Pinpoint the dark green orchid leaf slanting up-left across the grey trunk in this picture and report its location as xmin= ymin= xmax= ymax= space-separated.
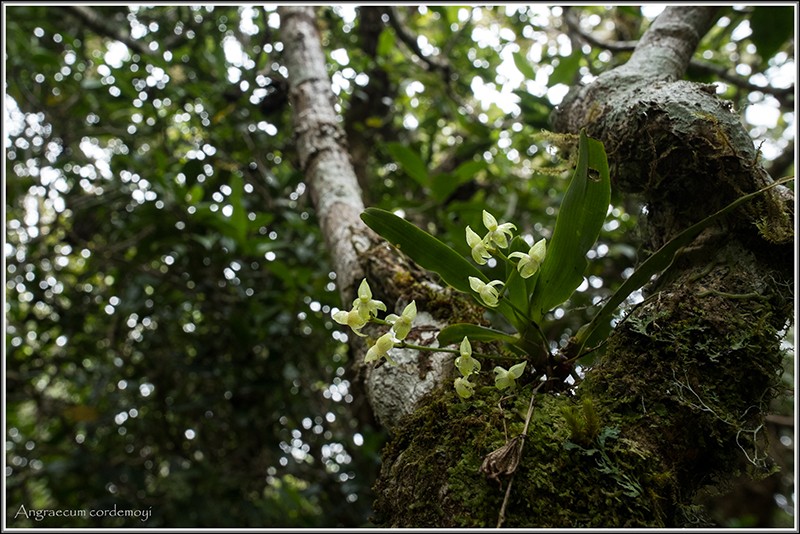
xmin=361 ymin=208 xmax=489 ymax=294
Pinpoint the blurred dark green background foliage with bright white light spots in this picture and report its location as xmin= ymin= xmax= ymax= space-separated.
xmin=4 ymin=5 xmax=796 ymax=527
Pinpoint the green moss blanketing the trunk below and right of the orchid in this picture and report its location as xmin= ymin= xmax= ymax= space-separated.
xmin=375 ymin=241 xmax=785 ymax=528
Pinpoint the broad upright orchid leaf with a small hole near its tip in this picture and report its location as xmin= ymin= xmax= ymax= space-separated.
xmin=531 ymin=130 xmax=611 ymax=323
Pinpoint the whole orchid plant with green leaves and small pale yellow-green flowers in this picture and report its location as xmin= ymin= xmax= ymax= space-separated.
xmin=333 ymin=131 xmax=785 ymax=398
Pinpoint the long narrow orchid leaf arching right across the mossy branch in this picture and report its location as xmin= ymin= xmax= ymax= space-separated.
xmin=575 ymin=176 xmax=794 ymax=354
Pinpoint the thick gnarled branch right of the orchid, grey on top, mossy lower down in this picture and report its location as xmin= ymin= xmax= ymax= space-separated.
xmin=553 ymin=2 xmax=793 ymax=524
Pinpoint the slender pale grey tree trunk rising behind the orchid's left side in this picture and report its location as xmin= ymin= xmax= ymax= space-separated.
xmin=278 ymin=6 xmax=452 ymax=428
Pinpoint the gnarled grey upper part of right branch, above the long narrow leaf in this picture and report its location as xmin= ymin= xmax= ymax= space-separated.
xmin=552 ymin=6 xmax=794 ymax=250
